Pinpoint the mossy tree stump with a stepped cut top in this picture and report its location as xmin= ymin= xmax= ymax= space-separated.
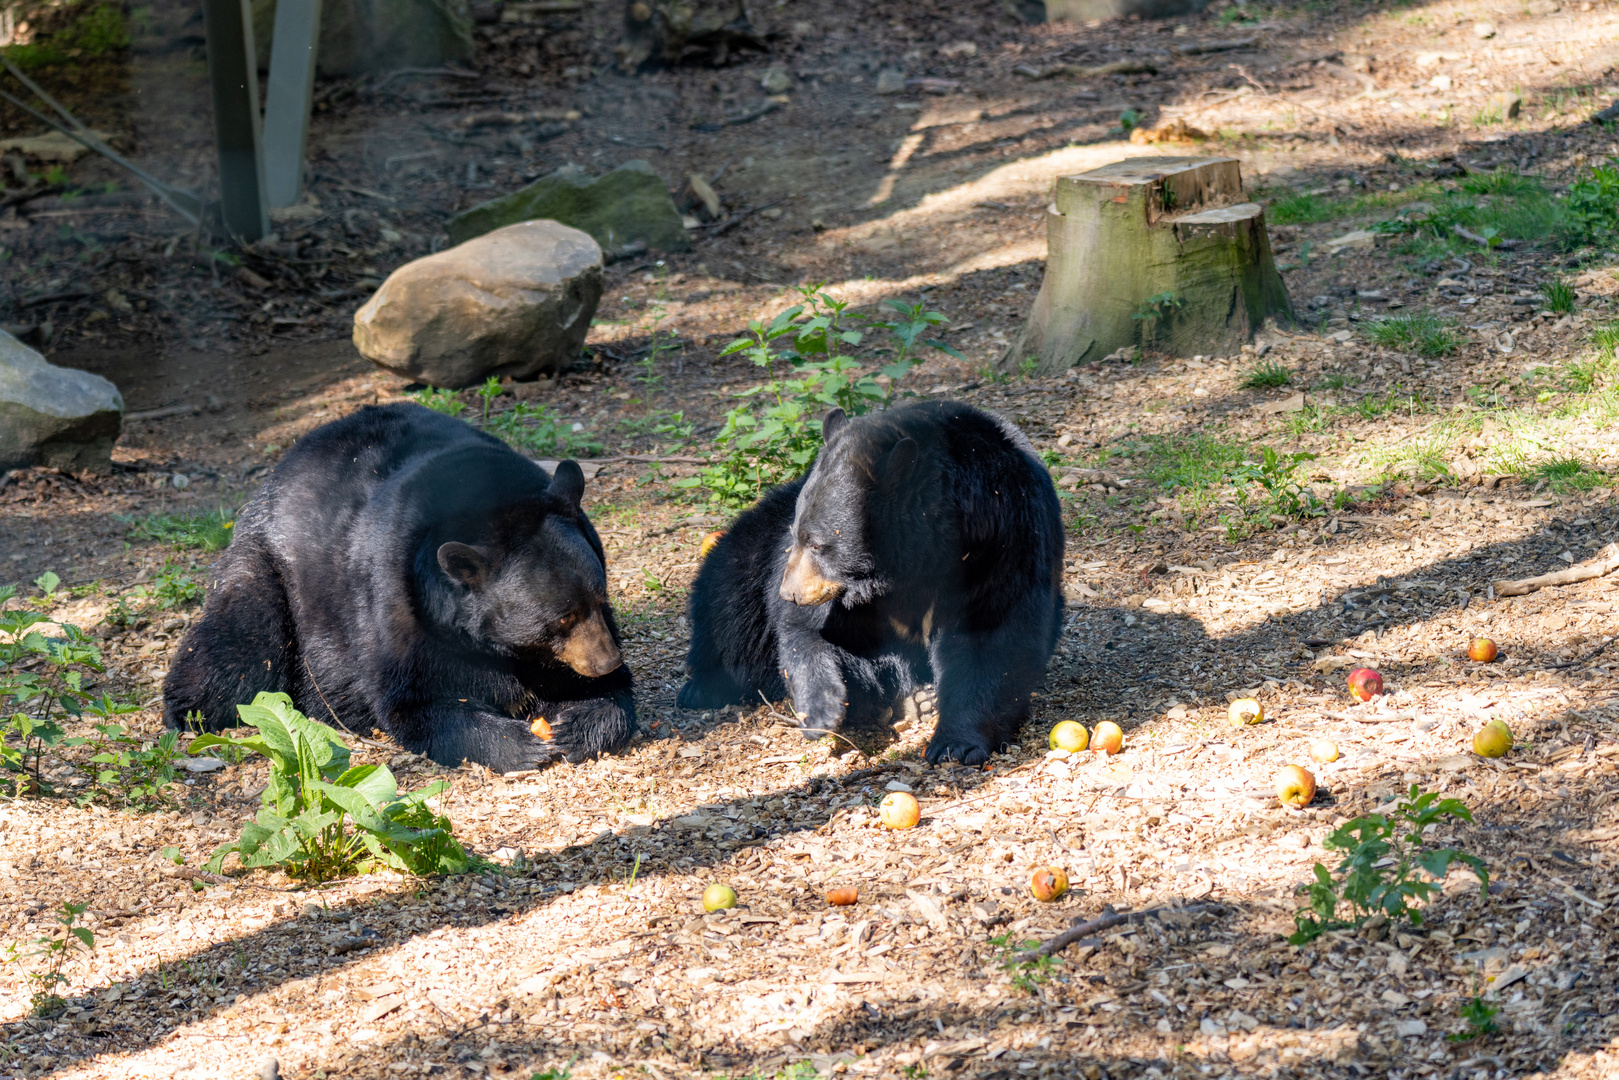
xmin=999 ymin=157 xmax=1294 ymax=376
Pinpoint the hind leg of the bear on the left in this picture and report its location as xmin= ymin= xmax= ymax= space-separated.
xmin=164 ymin=536 xmax=298 ymax=732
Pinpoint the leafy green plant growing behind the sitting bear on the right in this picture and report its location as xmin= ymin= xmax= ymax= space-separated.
xmin=675 ymin=283 xmax=967 ymax=507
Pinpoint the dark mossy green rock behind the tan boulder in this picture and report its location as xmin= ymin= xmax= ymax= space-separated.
xmin=445 ymin=160 xmax=691 ymax=251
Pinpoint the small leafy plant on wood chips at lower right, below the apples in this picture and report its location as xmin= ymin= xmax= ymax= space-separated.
xmin=1287 ymin=784 xmax=1489 ymax=946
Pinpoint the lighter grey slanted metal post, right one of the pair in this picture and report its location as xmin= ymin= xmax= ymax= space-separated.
xmin=264 ymin=0 xmax=321 ymax=207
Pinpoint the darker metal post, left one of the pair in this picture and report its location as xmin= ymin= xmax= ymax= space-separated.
xmin=202 ymin=0 xmax=270 ymax=241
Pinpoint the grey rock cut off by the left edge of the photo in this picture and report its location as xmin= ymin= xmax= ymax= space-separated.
xmin=0 ymin=330 xmax=123 ymax=473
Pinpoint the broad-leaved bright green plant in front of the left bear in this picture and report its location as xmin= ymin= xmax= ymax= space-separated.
xmin=189 ymin=693 xmax=468 ymax=881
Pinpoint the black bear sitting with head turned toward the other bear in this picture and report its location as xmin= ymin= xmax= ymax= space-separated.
xmin=678 ymin=402 xmax=1064 ymax=764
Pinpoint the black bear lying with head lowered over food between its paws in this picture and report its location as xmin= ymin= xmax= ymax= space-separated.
xmin=164 ymin=405 xmax=636 ymax=772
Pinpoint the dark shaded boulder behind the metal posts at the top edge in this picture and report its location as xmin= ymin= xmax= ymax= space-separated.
xmin=253 ymin=0 xmax=473 ymax=78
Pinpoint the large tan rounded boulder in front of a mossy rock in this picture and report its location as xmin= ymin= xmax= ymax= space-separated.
xmin=355 ymin=222 xmax=602 ymax=387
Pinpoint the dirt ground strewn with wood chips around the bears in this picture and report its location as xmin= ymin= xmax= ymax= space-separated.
xmin=0 ymin=0 xmax=1619 ymax=1080
